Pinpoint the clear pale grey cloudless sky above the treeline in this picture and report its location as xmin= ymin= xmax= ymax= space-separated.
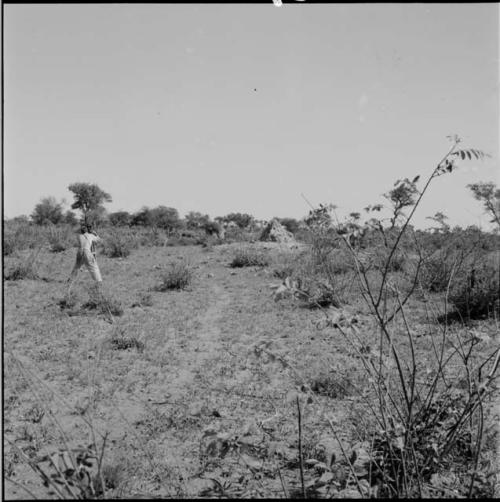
xmin=3 ymin=0 xmax=500 ymax=228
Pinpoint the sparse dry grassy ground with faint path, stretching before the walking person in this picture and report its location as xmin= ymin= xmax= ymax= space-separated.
xmin=4 ymin=244 xmax=498 ymax=499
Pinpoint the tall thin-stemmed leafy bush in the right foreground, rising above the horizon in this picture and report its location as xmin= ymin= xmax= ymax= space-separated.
xmin=280 ymin=138 xmax=500 ymax=498
